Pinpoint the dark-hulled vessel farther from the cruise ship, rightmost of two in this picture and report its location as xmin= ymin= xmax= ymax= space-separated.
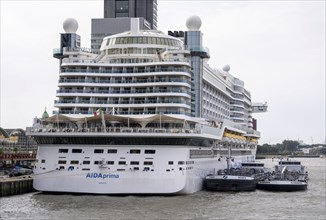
xmin=257 ymin=161 xmax=308 ymax=192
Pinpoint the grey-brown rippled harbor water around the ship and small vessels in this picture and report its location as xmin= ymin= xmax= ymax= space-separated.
xmin=0 ymin=158 xmax=326 ymax=220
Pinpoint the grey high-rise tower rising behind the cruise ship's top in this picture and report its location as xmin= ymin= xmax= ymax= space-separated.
xmin=91 ymin=0 xmax=157 ymax=50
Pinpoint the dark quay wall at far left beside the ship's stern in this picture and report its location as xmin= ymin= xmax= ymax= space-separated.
xmin=0 ymin=176 xmax=35 ymax=197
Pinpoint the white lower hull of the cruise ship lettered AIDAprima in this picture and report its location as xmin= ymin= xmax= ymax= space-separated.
xmin=33 ymin=146 xmax=253 ymax=194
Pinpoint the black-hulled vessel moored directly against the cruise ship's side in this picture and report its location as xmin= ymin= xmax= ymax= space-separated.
xmin=204 ymin=147 xmax=257 ymax=192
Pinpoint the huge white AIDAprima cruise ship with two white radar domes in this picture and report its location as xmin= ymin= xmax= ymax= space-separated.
xmin=27 ymin=13 xmax=267 ymax=195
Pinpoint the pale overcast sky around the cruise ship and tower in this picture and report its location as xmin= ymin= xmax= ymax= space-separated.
xmin=0 ymin=0 xmax=326 ymax=144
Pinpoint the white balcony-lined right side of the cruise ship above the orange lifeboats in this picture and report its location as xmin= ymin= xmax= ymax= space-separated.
xmin=203 ymin=65 xmax=252 ymax=128
